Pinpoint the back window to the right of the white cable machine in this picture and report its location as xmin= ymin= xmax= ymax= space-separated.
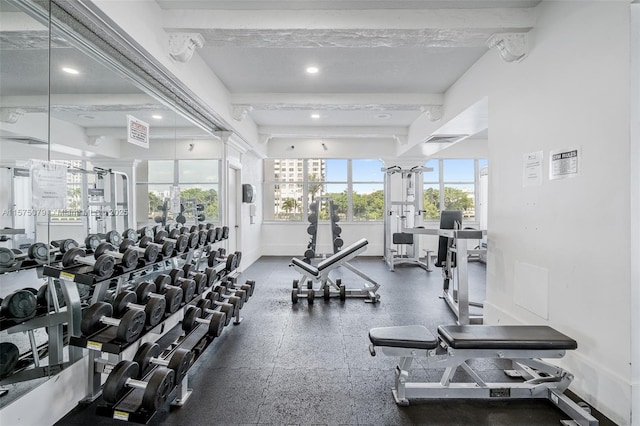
xmin=423 ymin=159 xmax=488 ymax=221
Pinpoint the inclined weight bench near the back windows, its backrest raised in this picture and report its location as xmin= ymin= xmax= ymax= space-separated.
xmin=289 ymin=238 xmax=380 ymax=303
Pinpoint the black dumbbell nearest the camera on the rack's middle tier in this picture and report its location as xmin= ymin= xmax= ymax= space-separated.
xmin=80 ymin=302 xmax=146 ymax=343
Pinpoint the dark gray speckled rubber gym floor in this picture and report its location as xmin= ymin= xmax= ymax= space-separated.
xmin=58 ymin=257 xmax=610 ymax=426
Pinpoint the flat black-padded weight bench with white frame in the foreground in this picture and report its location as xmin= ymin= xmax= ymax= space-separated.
xmin=369 ymin=325 xmax=598 ymax=426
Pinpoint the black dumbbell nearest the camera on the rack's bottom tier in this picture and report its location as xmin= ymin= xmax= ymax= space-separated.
xmin=102 ymin=360 xmax=175 ymax=412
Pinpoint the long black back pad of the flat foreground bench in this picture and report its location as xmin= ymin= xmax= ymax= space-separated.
xmin=438 ymin=325 xmax=578 ymax=350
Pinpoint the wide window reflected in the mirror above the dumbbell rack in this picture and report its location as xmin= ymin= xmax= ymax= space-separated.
xmin=136 ymin=160 xmax=220 ymax=223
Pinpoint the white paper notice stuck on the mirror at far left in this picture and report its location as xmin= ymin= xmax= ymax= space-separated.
xmin=31 ymin=160 xmax=67 ymax=210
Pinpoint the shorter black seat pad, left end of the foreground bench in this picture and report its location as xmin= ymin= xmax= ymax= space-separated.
xmin=369 ymin=325 xmax=438 ymax=349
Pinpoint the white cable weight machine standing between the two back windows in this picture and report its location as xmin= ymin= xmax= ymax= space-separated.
xmin=382 ymin=166 xmax=431 ymax=271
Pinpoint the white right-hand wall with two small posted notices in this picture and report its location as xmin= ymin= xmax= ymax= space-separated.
xmin=411 ymin=1 xmax=637 ymax=424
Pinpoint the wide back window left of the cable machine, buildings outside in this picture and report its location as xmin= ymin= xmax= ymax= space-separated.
xmin=264 ymin=159 xmax=384 ymax=221
